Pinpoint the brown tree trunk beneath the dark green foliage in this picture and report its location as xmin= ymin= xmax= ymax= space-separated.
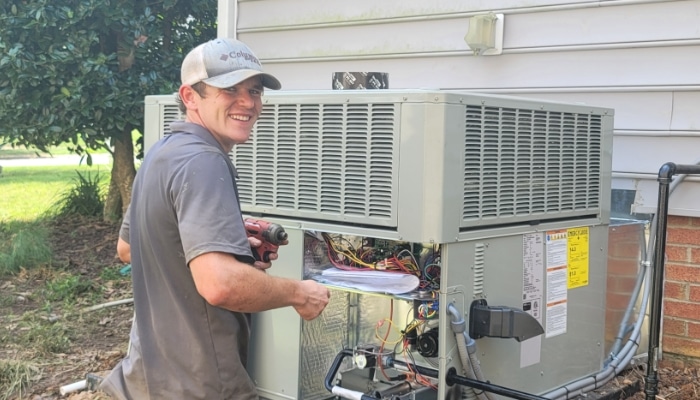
xmin=103 ymin=128 xmax=136 ymax=221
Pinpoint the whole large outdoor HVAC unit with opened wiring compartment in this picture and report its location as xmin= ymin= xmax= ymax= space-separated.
xmin=145 ymin=90 xmax=613 ymax=400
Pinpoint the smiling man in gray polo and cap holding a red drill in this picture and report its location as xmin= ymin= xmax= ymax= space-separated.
xmin=101 ymin=39 xmax=330 ymax=399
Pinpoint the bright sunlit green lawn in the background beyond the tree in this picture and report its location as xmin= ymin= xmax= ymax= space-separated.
xmin=0 ymin=165 xmax=111 ymax=223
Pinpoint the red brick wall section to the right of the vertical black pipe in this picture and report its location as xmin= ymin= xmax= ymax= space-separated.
xmin=661 ymin=216 xmax=700 ymax=358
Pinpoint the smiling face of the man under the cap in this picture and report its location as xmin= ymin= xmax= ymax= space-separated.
xmin=187 ymin=76 xmax=263 ymax=152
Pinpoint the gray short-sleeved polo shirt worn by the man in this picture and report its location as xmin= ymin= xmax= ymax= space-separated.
xmin=101 ymin=122 xmax=258 ymax=400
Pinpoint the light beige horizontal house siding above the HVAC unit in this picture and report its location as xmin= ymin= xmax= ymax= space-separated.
xmin=226 ymin=0 xmax=700 ymax=216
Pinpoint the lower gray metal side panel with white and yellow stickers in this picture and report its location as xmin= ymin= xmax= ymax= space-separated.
xmin=440 ymin=223 xmax=608 ymax=394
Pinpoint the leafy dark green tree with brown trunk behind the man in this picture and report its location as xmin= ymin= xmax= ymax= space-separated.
xmin=0 ymin=0 xmax=217 ymax=219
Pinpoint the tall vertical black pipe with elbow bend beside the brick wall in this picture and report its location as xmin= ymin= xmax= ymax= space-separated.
xmin=644 ymin=163 xmax=700 ymax=400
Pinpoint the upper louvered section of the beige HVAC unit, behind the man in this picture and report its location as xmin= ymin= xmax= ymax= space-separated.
xmin=145 ymin=90 xmax=613 ymax=243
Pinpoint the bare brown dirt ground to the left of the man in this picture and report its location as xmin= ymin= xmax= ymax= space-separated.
xmin=0 ymin=218 xmax=133 ymax=400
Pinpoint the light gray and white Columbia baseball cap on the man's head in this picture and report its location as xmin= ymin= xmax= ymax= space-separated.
xmin=180 ymin=38 xmax=282 ymax=89
